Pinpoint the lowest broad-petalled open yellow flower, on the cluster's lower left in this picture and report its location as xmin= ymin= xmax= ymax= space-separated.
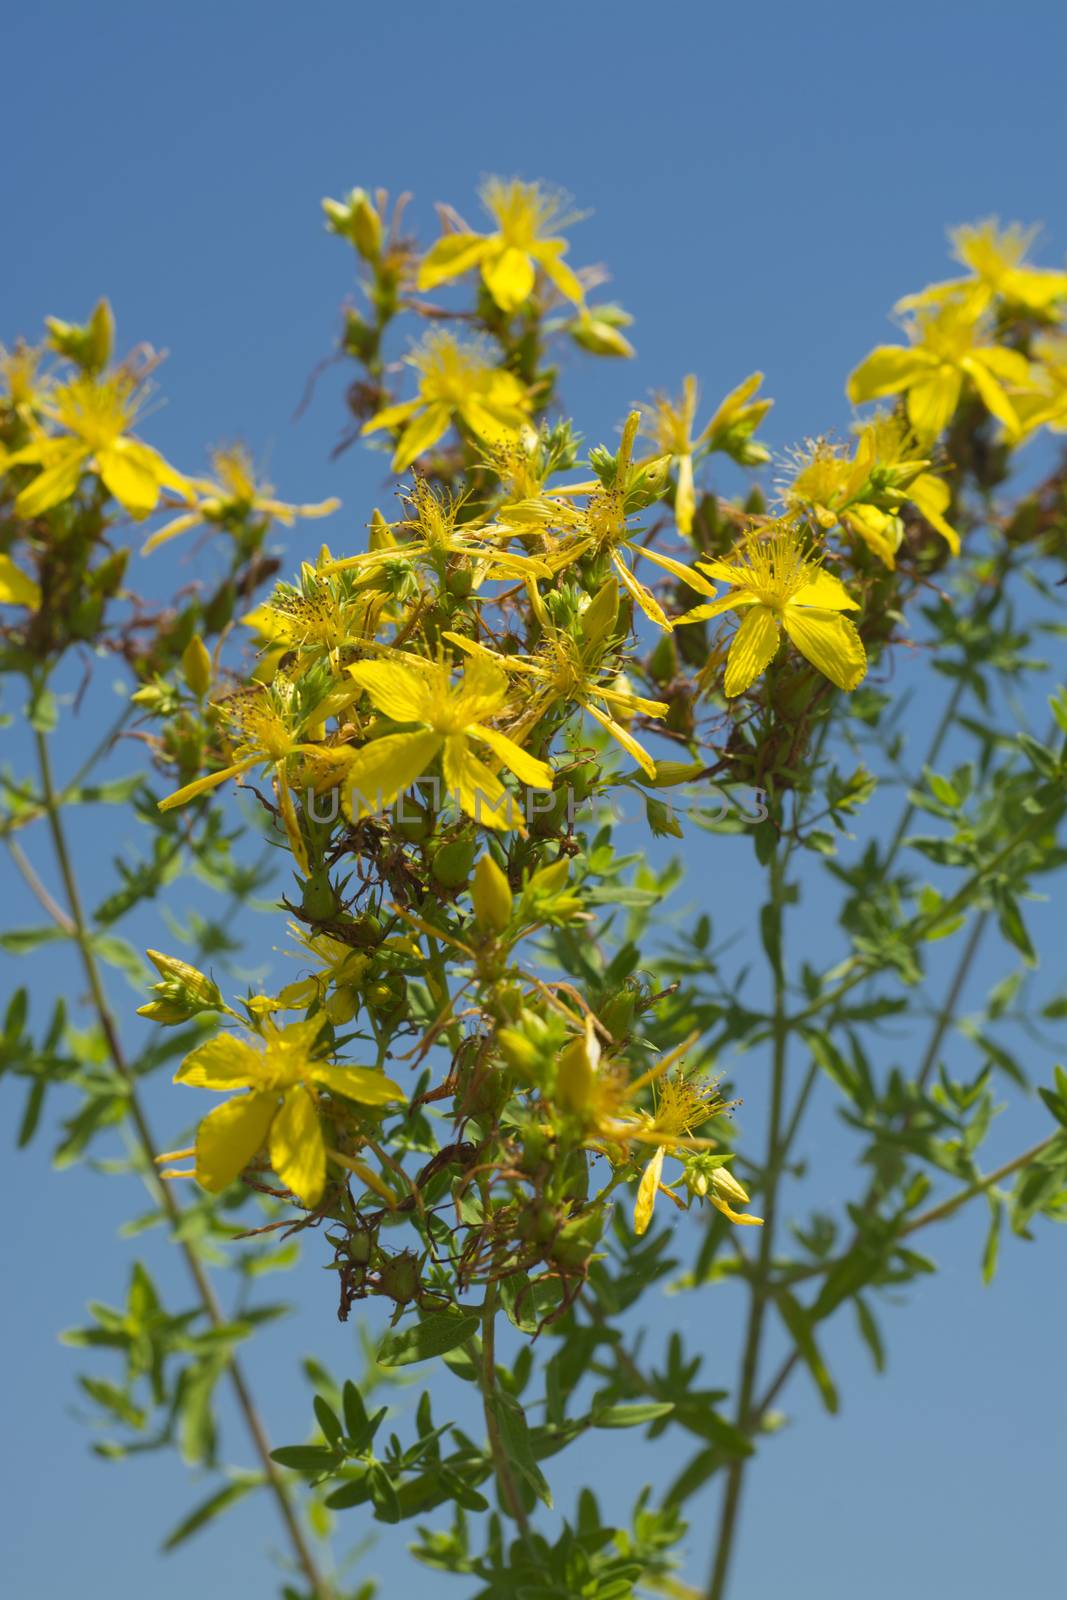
xmin=160 ymin=1016 xmax=405 ymax=1206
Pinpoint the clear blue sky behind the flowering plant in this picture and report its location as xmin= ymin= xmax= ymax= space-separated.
xmin=0 ymin=0 xmax=1067 ymax=1600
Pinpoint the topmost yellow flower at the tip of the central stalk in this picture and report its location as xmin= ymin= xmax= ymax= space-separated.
xmin=419 ymin=178 xmax=584 ymax=314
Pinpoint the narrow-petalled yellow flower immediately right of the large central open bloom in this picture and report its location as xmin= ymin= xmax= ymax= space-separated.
xmin=445 ymin=579 xmax=670 ymax=778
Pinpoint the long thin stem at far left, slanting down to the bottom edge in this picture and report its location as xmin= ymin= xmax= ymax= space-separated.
xmin=35 ymin=731 xmax=330 ymax=1600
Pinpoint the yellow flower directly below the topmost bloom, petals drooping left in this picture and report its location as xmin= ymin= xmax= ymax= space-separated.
xmin=363 ymin=330 xmax=531 ymax=472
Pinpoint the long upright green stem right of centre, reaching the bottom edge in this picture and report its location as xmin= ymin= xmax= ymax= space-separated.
xmin=707 ymin=851 xmax=789 ymax=1600
